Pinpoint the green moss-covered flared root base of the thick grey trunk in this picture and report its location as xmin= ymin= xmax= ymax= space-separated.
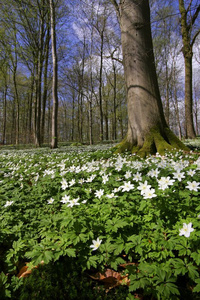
xmin=115 ymin=127 xmax=189 ymax=157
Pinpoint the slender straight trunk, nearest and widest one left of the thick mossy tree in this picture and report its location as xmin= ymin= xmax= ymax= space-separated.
xmin=49 ymin=0 xmax=58 ymax=149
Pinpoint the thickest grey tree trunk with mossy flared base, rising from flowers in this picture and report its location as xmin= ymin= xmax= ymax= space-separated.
xmin=112 ymin=0 xmax=189 ymax=156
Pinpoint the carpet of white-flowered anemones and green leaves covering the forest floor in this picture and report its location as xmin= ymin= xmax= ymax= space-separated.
xmin=0 ymin=145 xmax=200 ymax=300
